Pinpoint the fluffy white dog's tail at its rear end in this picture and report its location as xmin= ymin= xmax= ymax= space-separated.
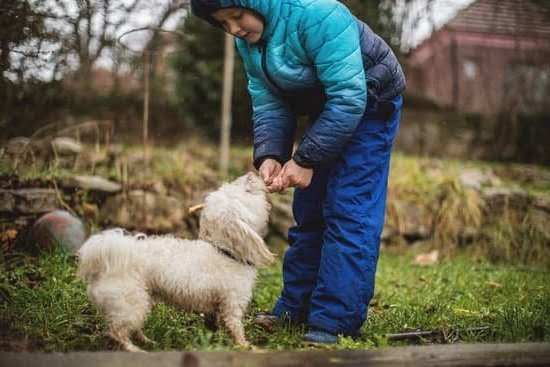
xmin=77 ymin=228 xmax=139 ymax=281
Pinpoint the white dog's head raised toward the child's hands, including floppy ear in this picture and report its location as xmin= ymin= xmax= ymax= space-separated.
xmin=199 ymin=172 xmax=274 ymax=265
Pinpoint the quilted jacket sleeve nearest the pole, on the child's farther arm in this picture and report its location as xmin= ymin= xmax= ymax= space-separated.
xmin=237 ymin=40 xmax=296 ymax=168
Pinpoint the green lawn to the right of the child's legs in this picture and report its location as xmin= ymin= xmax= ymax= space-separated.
xmin=365 ymin=249 xmax=550 ymax=342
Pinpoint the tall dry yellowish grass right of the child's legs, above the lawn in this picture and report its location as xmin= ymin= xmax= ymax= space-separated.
xmin=386 ymin=154 xmax=550 ymax=266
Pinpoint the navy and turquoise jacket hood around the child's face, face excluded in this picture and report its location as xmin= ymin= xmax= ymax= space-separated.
xmin=191 ymin=0 xmax=283 ymax=39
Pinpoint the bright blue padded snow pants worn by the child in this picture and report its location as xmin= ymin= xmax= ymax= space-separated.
xmin=273 ymin=96 xmax=402 ymax=336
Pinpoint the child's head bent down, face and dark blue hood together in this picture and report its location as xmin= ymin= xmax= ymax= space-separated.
xmin=191 ymin=0 xmax=269 ymax=43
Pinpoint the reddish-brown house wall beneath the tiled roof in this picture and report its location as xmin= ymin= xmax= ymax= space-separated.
xmin=406 ymin=28 xmax=550 ymax=114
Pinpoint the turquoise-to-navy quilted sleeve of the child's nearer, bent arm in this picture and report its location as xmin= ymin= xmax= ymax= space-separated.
xmin=294 ymin=1 xmax=367 ymax=167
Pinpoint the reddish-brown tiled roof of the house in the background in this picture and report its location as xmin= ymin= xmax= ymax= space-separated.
xmin=447 ymin=0 xmax=550 ymax=38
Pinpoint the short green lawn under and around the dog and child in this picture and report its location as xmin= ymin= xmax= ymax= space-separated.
xmin=0 ymin=248 xmax=550 ymax=352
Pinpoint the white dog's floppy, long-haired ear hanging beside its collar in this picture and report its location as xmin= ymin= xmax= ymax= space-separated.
xmin=225 ymin=218 xmax=275 ymax=266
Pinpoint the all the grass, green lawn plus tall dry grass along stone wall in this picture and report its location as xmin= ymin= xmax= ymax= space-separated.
xmin=0 ymin=139 xmax=550 ymax=352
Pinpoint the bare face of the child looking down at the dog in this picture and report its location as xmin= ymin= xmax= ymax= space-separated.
xmin=212 ymin=8 xmax=264 ymax=43
